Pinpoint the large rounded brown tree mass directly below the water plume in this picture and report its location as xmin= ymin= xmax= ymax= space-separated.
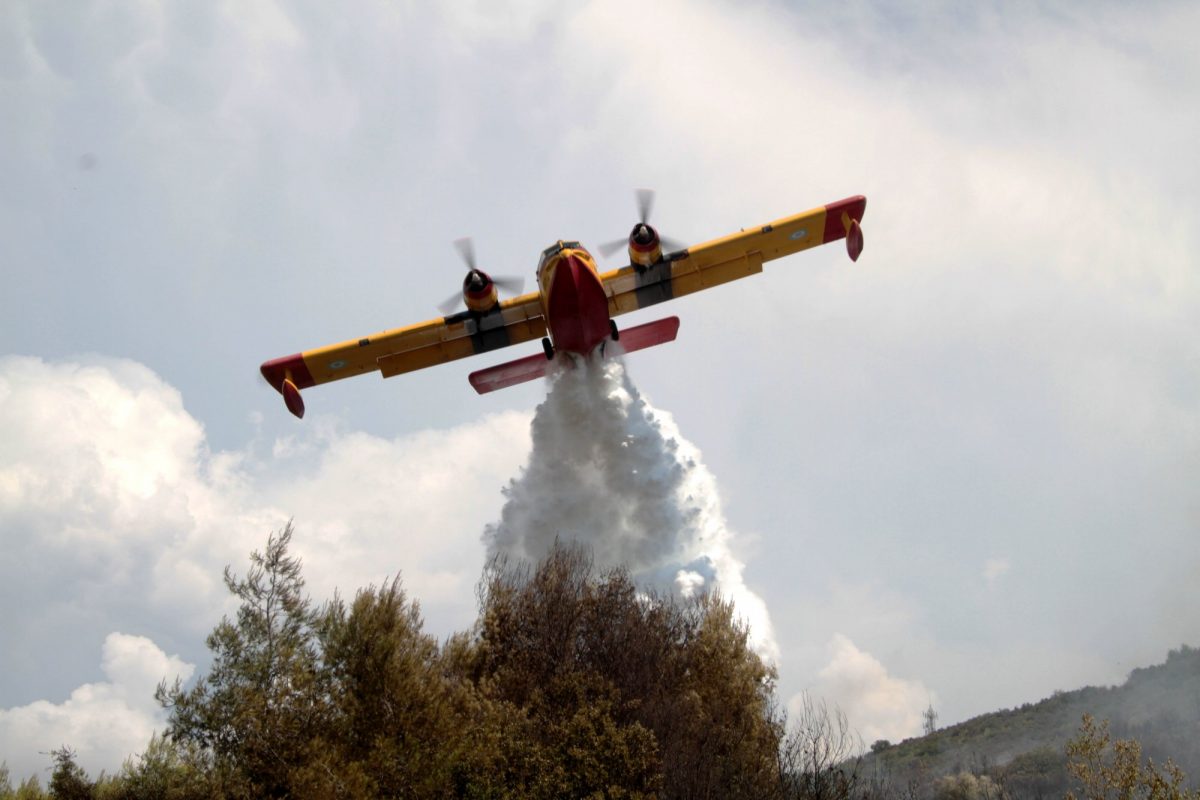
xmin=451 ymin=545 xmax=780 ymax=798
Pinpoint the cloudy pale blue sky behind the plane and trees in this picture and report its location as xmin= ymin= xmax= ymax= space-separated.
xmin=0 ymin=0 xmax=1200 ymax=776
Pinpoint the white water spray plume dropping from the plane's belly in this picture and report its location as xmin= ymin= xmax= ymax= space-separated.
xmin=484 ymin=350 xmax=779 ymax=663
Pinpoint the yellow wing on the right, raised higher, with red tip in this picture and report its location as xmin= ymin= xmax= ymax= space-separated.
xmin=600 ymin=196 xmax=866 ymax=317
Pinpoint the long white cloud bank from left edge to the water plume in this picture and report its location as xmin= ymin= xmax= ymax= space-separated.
xmin=0 ymin=357 xmax=529 ymax=769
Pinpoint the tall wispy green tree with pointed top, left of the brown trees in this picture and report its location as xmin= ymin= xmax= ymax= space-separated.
xmin=156 ymin=522 xmax=328 ymax=796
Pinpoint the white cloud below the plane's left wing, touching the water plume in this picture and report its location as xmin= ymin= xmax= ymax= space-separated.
xmin=259 ymin=411 xmax=529 ymax=633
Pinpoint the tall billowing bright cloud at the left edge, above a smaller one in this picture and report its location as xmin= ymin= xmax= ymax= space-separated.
xmin=0 ymin=357 xmax=279 ymax=681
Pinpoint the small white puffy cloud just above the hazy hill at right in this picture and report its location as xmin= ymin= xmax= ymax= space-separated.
xmin=788 ymin=633 xmax=936 ymax=742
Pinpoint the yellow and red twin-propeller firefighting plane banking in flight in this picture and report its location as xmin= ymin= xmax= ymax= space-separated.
xmin=262 ymin=190 xmax=866 ymax=417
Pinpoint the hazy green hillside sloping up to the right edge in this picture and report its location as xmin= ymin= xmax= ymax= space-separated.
xmin=860 ymin=645 xmax=1200 ymax=796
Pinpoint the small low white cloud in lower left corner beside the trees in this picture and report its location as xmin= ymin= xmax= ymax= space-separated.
xmin=0 ymin=633 xmax=194 ymax=780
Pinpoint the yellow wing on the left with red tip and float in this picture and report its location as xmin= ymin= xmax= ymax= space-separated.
xmin=260 ymin=291 xmax=546 ymax=416
